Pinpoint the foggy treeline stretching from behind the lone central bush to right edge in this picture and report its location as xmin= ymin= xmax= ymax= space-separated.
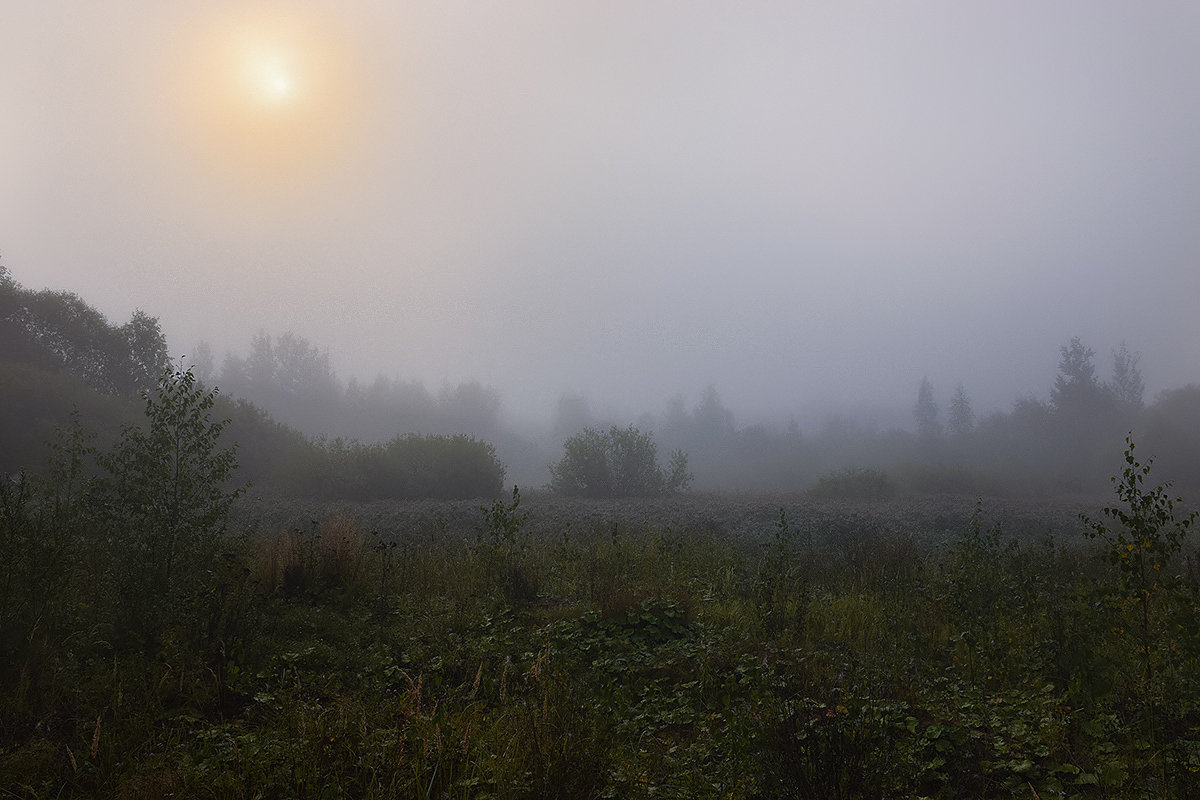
xmin=553 ymin=338 xmax=1200 ymax=494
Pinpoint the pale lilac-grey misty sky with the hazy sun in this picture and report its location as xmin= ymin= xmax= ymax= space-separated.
xmin=0 ymin=0 xmax=1200 ymax=429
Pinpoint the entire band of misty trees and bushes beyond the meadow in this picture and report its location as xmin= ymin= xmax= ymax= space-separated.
xmin=0 ymin=266 xmax=1200 ymax=499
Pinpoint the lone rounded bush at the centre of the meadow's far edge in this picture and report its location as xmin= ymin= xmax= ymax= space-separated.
xmin=550 ymin=426 xmax=691 ymax=498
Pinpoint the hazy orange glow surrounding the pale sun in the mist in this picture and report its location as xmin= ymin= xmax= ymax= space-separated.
xmin=165 ymin=5 xmax=365 ymax=204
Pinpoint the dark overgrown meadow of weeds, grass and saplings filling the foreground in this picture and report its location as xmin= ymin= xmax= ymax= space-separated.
xmin=0 ymin=373 xmax=1200 ymax=798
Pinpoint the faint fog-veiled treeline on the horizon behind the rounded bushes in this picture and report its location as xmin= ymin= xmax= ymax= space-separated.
xmin=162 ymin=280 xmax=1200 ymax=494
